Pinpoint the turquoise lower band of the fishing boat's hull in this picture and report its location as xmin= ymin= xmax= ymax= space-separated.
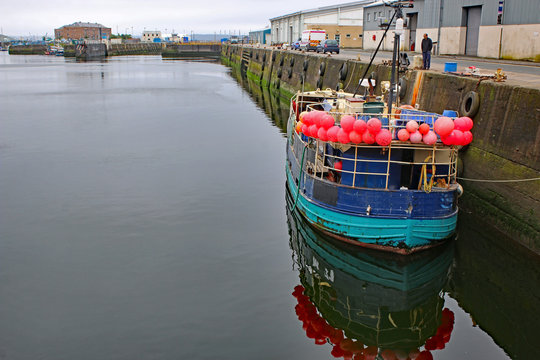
xmin=287 ymin=166 xmax=457 ymax=254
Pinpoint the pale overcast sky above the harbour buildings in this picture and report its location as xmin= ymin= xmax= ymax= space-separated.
xmin=0 ymin=0 xmax=350 ymax=36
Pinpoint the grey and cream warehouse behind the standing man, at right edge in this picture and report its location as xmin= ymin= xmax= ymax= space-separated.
xmin=364 ymin=0 xmax=540 ymax=59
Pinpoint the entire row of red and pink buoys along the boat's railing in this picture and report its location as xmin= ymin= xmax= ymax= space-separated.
xmin=296 ymin=110 xmax=473 ymax=146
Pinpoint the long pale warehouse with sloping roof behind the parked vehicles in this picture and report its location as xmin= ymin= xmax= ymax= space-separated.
xmin=270 ymin=0 xmax=374 ymax=48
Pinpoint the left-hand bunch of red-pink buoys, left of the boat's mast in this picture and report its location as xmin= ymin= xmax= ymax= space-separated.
xmin=296 ymin=111 xmax=392 ymax=146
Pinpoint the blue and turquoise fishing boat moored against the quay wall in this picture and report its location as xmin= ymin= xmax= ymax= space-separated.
xmin=286 ymin=1 xmax=472 ymax=254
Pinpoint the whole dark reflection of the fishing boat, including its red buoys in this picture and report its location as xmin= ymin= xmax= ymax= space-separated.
xmin=287 ymin=196 xmax=454 ymax=360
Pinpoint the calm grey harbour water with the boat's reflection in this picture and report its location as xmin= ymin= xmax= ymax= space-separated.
xmin=0 ymin=53 xmax=540 ymax=360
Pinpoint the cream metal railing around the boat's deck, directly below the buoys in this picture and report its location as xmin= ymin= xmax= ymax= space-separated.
xmin=296 ymin=134 xmax=457 ymax=191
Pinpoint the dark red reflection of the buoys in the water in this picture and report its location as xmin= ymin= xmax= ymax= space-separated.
xmin=292 ymin=285 xmax=454 ymax=360
